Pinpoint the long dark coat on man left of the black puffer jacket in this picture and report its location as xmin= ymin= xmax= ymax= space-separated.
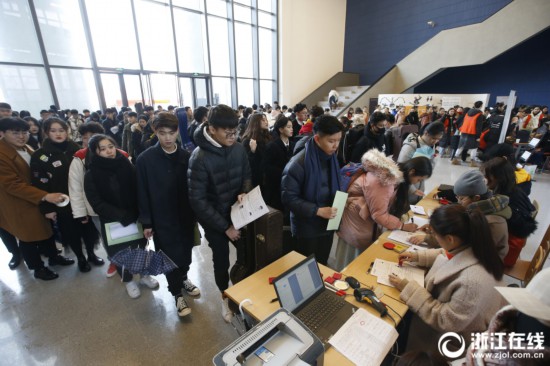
xmin=136 ymin=143 xmax=195 ymax=266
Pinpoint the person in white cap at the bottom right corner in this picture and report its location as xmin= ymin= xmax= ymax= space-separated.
xmin=466 ymin=268 xmax=550 ymax=366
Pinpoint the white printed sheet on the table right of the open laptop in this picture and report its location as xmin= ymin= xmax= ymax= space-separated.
xmin=329 ymin=309 xmax=398 ymax=366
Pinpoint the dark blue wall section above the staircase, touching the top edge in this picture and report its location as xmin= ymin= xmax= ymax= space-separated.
xmin=344 ymin=0 xmax=511 ymax=85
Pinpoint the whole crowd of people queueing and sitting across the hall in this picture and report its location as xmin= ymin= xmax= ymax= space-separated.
xmin=0 ymin=96 xmax=550 ymax=360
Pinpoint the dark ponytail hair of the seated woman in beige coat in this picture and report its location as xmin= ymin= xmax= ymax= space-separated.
xmin=430 ymin=204 xmax=504 ymax=281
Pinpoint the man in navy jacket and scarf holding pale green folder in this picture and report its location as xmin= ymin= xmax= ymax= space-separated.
xmin=281 ymin=114 xmax=343 ymax=265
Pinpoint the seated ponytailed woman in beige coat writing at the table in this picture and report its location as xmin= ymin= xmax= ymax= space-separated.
xmin=390 ymin=204 xmax=504 ymax=350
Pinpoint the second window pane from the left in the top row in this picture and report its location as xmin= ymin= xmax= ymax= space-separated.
xmin=34 ymin=0 xmax=92 ymax=67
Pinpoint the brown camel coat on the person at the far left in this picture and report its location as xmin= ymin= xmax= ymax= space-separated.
xmin=0 ymin=140 xmax=53 ymax=242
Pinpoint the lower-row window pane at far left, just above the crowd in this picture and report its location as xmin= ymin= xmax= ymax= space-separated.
xmin=0 ymin=65 xmax=53 ymax=116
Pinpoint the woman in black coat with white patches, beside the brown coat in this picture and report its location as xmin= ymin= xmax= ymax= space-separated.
xmin=30 ymin=117 xmax=105 ymax=272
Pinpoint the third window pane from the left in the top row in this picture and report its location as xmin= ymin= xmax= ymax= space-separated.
xmin=86 ymin=0 xmax=143 ymax=69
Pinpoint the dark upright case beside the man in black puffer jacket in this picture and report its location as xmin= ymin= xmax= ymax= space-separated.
xmin=254 ymin=207 xmax=284 ymax=271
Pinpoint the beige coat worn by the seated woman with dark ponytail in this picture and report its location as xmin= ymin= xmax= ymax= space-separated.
xmin=401 ymin=248 xmax=504 ymax=350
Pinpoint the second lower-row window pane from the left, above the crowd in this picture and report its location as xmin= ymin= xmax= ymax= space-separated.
xmin=52 ymin=68 xmax=99 ymax=112
